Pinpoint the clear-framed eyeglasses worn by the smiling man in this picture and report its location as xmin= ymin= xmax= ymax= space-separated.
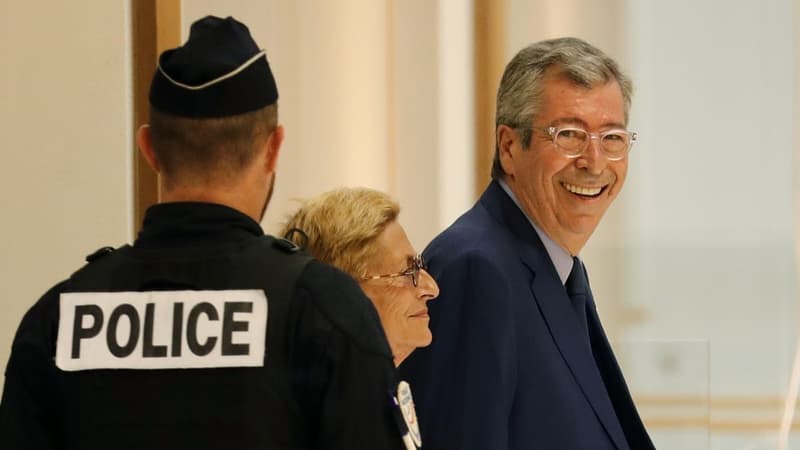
xmin=533 ymin=127 xmax=636 ymax=161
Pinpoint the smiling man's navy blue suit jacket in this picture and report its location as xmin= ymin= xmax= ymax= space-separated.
xmin=400 ymin=182 xmax=653 ymax=450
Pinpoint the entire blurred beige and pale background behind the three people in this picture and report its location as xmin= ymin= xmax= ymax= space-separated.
xmin=0 ymin=0 xmax=800 ymax=450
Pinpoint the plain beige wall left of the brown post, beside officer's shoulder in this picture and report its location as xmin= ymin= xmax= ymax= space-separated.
xmin=0 ymin=1 xmax=131 ymax=394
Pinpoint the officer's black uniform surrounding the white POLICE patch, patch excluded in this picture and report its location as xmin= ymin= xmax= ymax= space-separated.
xmin=0 ymin=203 xmax=402 ymax=449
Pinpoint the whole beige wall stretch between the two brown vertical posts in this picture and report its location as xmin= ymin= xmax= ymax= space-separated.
xmin=182 ymin=0 xmax=472 ymax=250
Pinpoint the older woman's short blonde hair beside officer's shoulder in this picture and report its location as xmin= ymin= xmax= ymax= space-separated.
xmin=281 ymin=188 xmax=400 ymax=279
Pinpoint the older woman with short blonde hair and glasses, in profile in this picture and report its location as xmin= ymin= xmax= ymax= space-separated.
xmin=282 ymin=188 xmax=439 ymax=365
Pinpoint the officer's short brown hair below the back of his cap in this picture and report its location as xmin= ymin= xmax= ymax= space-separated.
xmin=150 ymin=103 xmax=278 ymax=185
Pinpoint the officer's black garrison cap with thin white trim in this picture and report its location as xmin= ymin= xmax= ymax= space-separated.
xmin=150 ymin=16 xmax=278 ymax=118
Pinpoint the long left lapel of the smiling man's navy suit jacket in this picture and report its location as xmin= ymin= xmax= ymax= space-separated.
xmin=480 ymin=181 xmax=628 ymax=450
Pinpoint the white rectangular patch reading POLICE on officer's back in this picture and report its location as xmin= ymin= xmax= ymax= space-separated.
xmin=56 ymin=289 xmax=268 ymax=371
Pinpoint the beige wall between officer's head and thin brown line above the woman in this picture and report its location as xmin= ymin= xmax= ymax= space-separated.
xmin=182 ymin=0 xmax=390 ymax=237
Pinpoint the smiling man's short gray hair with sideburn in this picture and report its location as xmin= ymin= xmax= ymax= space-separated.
xmin=492 ymin=37 xmax=633 ymax=179
